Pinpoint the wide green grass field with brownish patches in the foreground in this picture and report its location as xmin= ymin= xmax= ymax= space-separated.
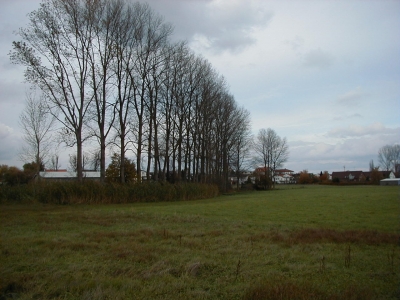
xmin=0 ymin=186 xmax=400 ymax=299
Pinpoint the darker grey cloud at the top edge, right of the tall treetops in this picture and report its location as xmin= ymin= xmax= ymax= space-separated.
xmin=144 ymin=0 xmax=272 ymax=53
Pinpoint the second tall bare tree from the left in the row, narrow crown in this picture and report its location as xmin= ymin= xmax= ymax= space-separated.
xmin=86 ymin=1 xmax=119 ymax=181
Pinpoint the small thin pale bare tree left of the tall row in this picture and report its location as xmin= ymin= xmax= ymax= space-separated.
xmin=19 ymin=90 xmax=54 ymax=172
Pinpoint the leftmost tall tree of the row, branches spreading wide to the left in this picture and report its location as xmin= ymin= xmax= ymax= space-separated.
xmin=10 ymin=0 xmax=93 ymax=181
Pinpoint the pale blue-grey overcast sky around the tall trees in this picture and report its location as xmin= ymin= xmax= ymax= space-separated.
xmin=0 ymin=0 xmax=400 ymax=172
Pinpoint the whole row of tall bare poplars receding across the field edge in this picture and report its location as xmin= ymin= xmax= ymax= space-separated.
xmin=10 ymin=0 xmax=250 ymax=189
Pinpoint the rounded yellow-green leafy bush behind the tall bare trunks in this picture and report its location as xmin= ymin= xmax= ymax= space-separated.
xmin=106 ymin=153 xmax=137 ymax=183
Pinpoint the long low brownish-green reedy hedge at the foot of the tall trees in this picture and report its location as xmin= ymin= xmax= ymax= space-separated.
xmin=0 ymin=181 xmax=219 ymax=204
